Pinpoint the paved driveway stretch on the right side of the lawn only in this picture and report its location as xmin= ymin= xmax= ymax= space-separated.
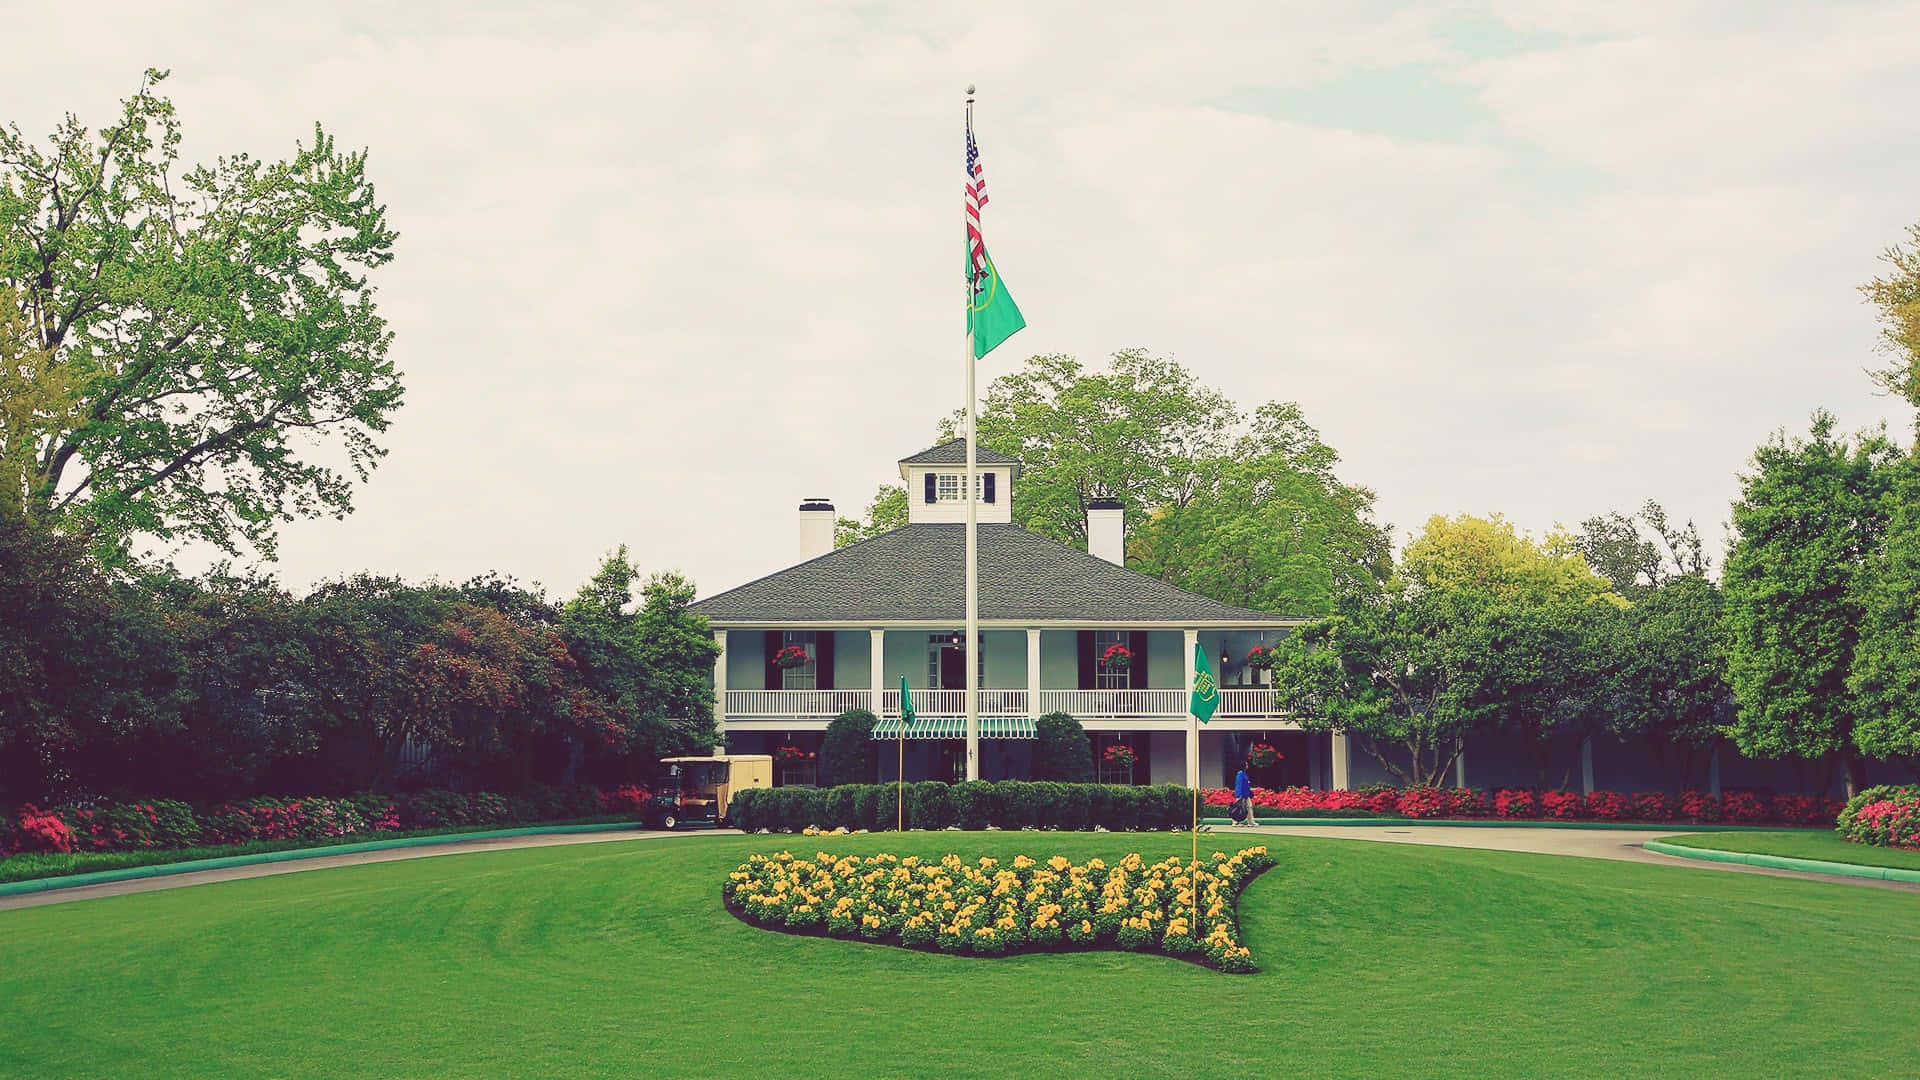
xmin=1213 ymin=824 xmax=1920 ymax=892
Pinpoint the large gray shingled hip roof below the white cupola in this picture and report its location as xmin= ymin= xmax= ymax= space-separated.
xmin=693 ymin=525 xmax=1292 ymax=626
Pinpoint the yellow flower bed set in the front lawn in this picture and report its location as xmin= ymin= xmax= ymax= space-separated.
xmin=720 ymin=846 xmax=1273 ymax=972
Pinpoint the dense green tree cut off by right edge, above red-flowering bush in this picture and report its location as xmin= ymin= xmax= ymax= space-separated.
xmin=1847 ymin=448 xmax=1920 ymax=776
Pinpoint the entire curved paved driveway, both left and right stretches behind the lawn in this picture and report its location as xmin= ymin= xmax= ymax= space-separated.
xmin=0 ymin=824 xmax=1920 ymax=911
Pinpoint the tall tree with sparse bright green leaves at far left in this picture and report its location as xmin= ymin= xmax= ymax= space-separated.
xmin=0 ymin=71 xmax=401 ymax=559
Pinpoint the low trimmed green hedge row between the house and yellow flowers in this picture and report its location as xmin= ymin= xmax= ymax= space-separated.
xmin=728 ymin=780 xmax=1194 ymax=832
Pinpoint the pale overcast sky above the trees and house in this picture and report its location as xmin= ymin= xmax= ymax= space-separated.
xmin=0 ymin=0 xmax=1920 ymax=596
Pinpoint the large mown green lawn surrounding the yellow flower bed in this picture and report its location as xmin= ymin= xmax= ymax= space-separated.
xmin=0 ymin=832 xmax=1920 ymax=1078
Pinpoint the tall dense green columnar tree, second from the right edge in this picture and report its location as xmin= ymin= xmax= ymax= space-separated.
xmin=1724 ymin=409 xmax=1897 ymax=792
